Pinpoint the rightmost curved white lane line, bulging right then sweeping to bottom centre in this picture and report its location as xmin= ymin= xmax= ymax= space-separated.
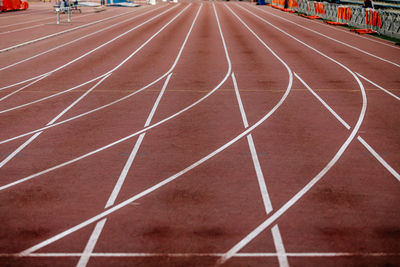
xmin=217 ymin=3 xmax=367 ymax=264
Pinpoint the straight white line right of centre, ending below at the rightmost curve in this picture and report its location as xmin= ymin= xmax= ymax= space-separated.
xmin=232 ymin=73 xmax=273 ymax=214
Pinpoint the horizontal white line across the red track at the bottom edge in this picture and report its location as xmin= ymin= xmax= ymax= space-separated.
xmin=0 ymin=252 xmax=400 ymax=258
